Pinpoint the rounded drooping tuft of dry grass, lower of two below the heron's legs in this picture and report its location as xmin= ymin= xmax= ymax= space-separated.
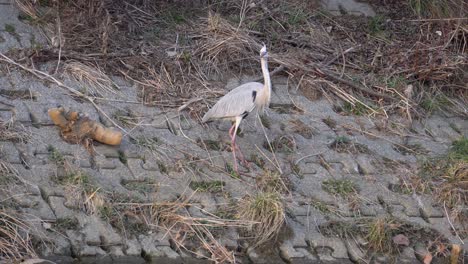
xmin=238 ymin=192 xmax=286 ymax=247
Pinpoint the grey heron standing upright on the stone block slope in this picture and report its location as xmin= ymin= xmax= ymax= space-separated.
xmin=202 ymin=44 xmax=271 ymax=172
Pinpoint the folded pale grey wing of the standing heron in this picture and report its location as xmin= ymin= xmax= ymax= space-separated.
xmin=202 ymin=83 xmax=263 ymax=122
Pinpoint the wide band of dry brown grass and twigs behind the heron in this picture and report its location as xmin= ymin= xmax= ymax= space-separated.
xmin=12 ymin=0 xmax=468 ymax=119
